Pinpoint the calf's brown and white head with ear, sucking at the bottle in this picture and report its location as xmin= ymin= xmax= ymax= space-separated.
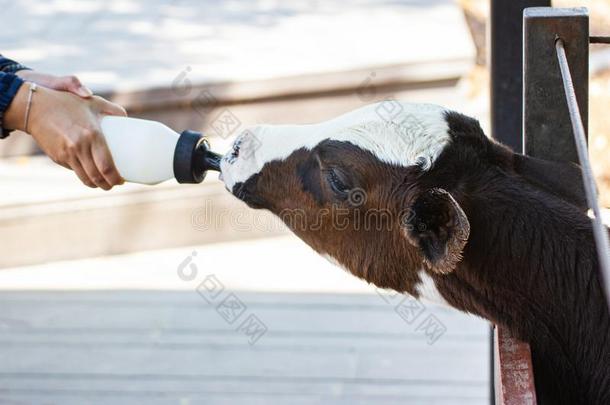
xmin=221 ymin=102 xmax=584 ymax=297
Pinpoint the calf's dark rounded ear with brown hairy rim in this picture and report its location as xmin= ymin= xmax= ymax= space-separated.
xmin=402 ymin=188 xmax=470 ymax=274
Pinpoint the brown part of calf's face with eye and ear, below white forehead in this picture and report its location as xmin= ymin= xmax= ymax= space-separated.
xmin=228 ymin=136 xmax=470 ymax=296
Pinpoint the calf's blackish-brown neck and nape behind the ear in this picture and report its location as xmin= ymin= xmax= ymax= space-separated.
xmin=426 ymin=114 xmax=610 ymax=404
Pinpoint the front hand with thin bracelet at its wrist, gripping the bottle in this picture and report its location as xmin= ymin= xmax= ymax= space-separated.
xmin=4 ymin=83 xmax=127 ymax=190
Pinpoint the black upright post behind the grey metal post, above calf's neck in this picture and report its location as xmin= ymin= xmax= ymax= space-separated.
xmin=490 ymin=0 xmax=551 ymax=152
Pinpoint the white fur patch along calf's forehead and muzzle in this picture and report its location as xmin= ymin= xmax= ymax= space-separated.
xmin=221 ymin=100 xmax=450 ymax=190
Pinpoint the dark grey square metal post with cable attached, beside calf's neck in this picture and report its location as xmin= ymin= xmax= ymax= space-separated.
xmin=523 ymin=7 xmax=589 ymax=159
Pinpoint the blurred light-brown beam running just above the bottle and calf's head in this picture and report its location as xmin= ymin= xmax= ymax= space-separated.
xmin=101 ymin=64 xmax=460 ymax=114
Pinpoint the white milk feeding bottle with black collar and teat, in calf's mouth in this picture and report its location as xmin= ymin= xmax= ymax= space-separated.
xmin=101 ymin=116 xmax=221 ymax=184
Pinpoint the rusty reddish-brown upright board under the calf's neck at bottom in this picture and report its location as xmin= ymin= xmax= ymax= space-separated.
xmin=494 ymin=326 xmax=536 ymax=405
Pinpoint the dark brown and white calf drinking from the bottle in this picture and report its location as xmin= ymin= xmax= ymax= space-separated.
xmin=221 ymin=103 xmax=610 ymax=404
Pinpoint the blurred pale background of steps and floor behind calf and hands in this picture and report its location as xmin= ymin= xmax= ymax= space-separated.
xmin=0 ymin=0 xmax=610 ymax=404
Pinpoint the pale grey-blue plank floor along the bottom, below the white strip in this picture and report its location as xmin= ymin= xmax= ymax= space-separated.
xmin=0 ymin=291 xmax=488 ymax=404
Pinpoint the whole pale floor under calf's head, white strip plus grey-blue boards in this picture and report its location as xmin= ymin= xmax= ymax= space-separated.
xmin=0 ymin=236 xmax=489 ymax=405
